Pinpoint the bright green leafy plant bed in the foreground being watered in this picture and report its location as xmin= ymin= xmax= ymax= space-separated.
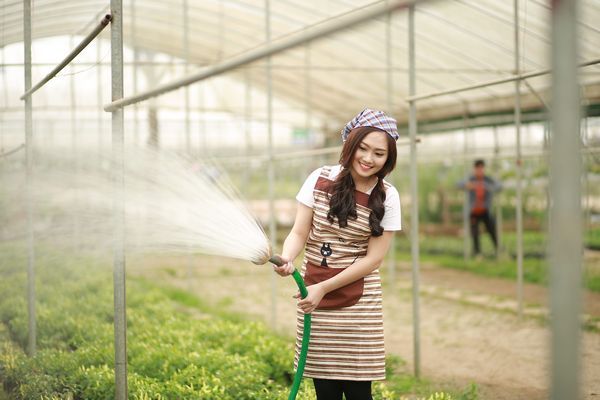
xmin=0 ymin=245 xmax=464 ymax=400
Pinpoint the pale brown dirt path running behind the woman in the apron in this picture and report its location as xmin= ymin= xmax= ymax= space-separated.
xmin=128 ymin=257 xmax=600 ymax=400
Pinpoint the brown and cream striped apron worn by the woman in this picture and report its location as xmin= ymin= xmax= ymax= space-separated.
xmin=294 ymin=167 xmax=389 ymax=381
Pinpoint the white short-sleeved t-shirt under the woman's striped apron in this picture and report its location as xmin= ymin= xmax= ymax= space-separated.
xmin=296 ymin=165 xmax=402 ymax=231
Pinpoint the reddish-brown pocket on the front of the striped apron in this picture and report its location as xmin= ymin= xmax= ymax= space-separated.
xmin=304 ymin=262 xmax=365 ymax=309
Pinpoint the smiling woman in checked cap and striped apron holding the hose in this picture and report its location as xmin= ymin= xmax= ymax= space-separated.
xmin=273 ymin=109 xmax=401 ymax=400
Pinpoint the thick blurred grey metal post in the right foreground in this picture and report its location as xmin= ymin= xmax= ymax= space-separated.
xmin=548 ymin=0 xmax=583 ymax=400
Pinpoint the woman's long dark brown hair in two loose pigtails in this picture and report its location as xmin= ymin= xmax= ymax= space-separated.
xmin=327 ymin=126 xmax=397 ymax=236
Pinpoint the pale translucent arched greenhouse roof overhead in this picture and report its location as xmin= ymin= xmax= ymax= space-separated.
xmin=0 ymin=0 xmax=600 ymax=129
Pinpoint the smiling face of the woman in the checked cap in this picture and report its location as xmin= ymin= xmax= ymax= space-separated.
xmin=352 ymin=131 xmax=388 ymax=178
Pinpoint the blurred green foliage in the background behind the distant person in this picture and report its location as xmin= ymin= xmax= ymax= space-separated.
xmin=224 ymin=154 xmax=600 ymax=234
